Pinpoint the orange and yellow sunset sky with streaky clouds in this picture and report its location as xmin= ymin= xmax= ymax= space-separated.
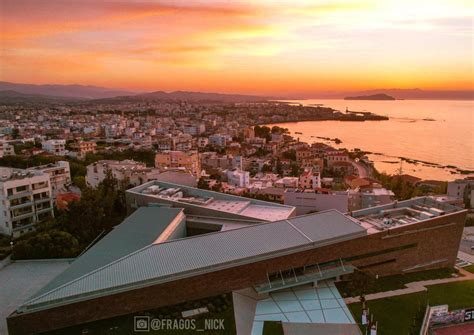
xmin=0 ymin=0 xmax=474 ymax=94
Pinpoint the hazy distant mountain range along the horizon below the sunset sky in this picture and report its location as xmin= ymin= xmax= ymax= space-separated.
xmin=0 ymin=81 xmax=474 ymax=103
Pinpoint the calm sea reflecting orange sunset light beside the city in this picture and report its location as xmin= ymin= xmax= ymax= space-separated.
xmin=268 ymin=99 xmax=474 ymax=180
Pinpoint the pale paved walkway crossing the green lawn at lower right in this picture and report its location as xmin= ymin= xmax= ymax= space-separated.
xmin=344 ymin=269 xmax=474 ymax=304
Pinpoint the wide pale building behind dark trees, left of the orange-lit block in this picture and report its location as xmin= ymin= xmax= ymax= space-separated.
xmin=86 ymin=160 xmax=161 ymax=188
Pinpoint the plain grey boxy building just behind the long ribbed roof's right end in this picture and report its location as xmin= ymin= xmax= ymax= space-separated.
xmin=284 ymin=189 xmax=349 ymax=215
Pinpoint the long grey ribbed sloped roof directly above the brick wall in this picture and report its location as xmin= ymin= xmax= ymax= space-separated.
xmin=21 ymin=210 xmax=366 ymax=310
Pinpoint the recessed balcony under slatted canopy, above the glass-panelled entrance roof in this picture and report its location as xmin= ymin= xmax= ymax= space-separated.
xmin=254 ymin=261 xmax=356 ymax=293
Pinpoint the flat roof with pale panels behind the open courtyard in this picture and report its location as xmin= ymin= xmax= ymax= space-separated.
xmin=127 ymin=181 xmax=295 ymax=221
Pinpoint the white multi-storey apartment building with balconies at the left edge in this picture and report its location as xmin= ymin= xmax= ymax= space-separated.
xmin=0 ymin=167 xmax=54 ymax=237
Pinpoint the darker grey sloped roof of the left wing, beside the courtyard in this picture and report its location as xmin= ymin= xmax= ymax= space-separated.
xmin=27 ymin=207 xmax=183 ymax=297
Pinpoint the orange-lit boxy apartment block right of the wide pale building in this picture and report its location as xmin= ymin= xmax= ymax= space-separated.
xmin=155 ymin=150 xmax=201 ymax=179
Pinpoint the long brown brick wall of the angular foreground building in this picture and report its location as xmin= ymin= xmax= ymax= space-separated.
xmin=7 ymin=212 xmax=466 ymax=335
